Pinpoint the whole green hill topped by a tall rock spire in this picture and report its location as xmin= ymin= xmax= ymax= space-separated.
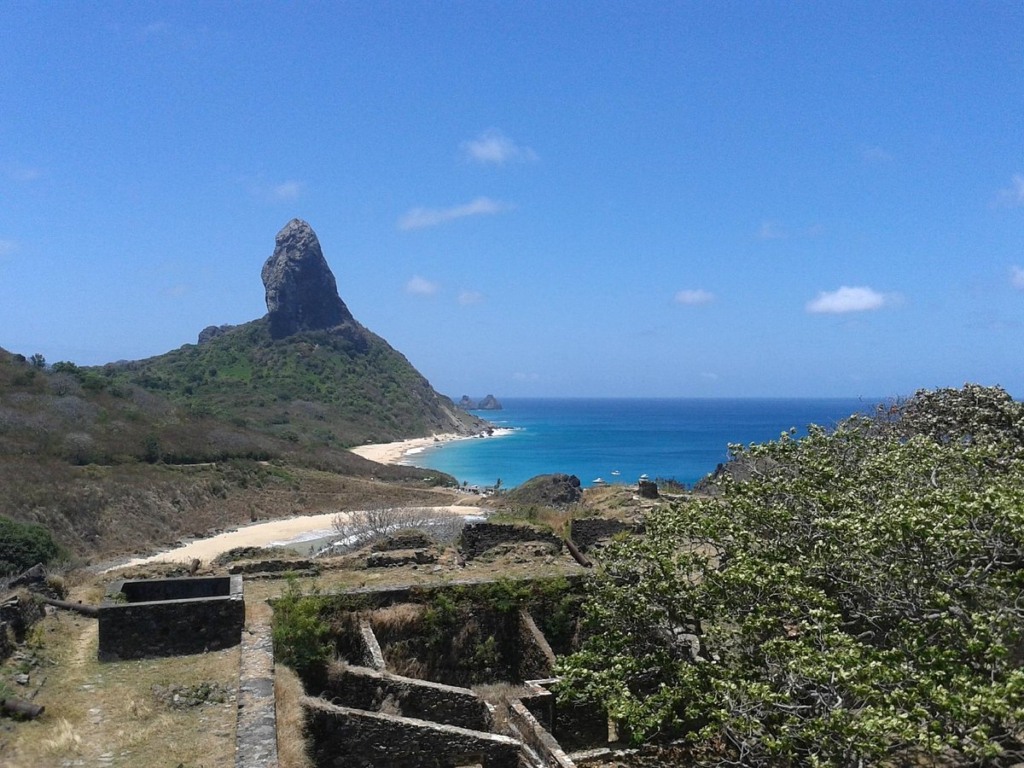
xmin=103 ymin=219 xmax=486 ymax=447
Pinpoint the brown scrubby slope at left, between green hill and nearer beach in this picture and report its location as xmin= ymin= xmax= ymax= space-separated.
xmin=0 ymin=349 xmax=454 ymax=556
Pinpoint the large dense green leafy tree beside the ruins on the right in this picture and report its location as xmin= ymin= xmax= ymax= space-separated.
xmin=560 ymin=385 xmax=1024 ymax=766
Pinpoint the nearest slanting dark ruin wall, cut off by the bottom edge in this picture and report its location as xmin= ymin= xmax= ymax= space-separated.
xmin=302 ymin=696 xmax=522 ymax=768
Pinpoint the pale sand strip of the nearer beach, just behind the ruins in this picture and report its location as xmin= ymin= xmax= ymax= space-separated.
xmin=111 ymin=504 xmax=480 ymax=569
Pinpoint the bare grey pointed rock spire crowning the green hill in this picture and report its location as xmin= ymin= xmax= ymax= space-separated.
xmin=262 ymin=219 xmax=352 ymax=339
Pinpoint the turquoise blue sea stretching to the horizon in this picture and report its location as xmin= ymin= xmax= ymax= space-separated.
xmin=411 ymin=398 xmax=880 ymax=487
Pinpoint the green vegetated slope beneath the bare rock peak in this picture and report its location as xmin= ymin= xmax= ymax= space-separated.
xmin=95 ymin=317 xmax=485 ymax=447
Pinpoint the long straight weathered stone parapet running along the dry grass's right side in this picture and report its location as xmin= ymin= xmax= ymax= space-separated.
xmin=234 ymin=606 xmax=278 ymax=768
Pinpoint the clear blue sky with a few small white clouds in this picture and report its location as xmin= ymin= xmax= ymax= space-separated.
xmin=0 ymin=1 xmax=1024 ymax=397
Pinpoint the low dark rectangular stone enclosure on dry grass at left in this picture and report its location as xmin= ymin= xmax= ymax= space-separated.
xmin=98 ymin=577 xmax=246 ymax=662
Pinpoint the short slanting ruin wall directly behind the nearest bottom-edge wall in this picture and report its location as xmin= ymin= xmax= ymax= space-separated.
xmin=319 ymin=665 xmax=492 ymax=730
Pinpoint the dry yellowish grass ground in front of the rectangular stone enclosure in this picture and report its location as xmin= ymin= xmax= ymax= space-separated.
xmin=0 ymin=595 xmax=239 ymax=768
